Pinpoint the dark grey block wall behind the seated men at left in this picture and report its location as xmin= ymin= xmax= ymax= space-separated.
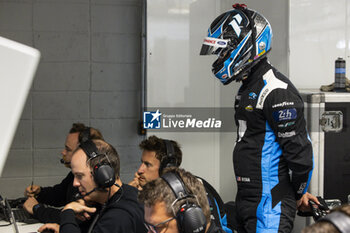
xmin=0 ymin=0 xmax=142 ymax=197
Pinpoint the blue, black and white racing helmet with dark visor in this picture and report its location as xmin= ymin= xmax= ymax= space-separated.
xmin=200 ymin=4 xmax=272 ymax=85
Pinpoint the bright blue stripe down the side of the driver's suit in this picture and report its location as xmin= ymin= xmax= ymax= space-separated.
xmin=256 ymin=122 xmax=282 ymax=233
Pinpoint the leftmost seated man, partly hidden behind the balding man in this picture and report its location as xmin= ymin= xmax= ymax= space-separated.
xmin=23 ymin=123 xmax=103 ymax=223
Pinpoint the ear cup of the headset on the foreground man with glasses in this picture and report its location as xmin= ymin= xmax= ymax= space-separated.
xmin=176 ymin=204 xmax=207 ymax=233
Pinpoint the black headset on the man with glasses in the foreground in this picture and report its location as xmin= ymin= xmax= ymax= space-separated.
xmin=161 ymin=172 xmax=207 ymax=233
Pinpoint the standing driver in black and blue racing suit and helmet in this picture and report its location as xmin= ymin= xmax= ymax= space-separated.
xmin=201 ymin=4 xmax=318 ymax=233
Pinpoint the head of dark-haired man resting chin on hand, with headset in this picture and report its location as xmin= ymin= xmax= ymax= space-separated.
xmin=129 ymin=135 xmax=182 ymax=190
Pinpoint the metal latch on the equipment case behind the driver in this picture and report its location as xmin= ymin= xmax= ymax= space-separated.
xmin=320 ymin=111 xmax=343 ymax=133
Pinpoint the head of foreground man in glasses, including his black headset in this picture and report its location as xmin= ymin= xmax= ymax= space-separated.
xmin=139 ymin=167 xmax=224 ymax=233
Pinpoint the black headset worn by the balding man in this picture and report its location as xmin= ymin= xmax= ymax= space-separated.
xmin=79 ymin=140 xmax=115 ymax=189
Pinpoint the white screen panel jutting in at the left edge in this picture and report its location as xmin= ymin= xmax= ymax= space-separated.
xmin=0 ymin=37 xmax=40 ymax=176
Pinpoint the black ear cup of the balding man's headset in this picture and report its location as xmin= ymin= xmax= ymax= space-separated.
xmin=94 ymin=164 xmax=115 ymax=188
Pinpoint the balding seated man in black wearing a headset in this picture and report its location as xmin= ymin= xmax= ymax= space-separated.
xmin=40 ymin=140 xmax=146 ymax=233
